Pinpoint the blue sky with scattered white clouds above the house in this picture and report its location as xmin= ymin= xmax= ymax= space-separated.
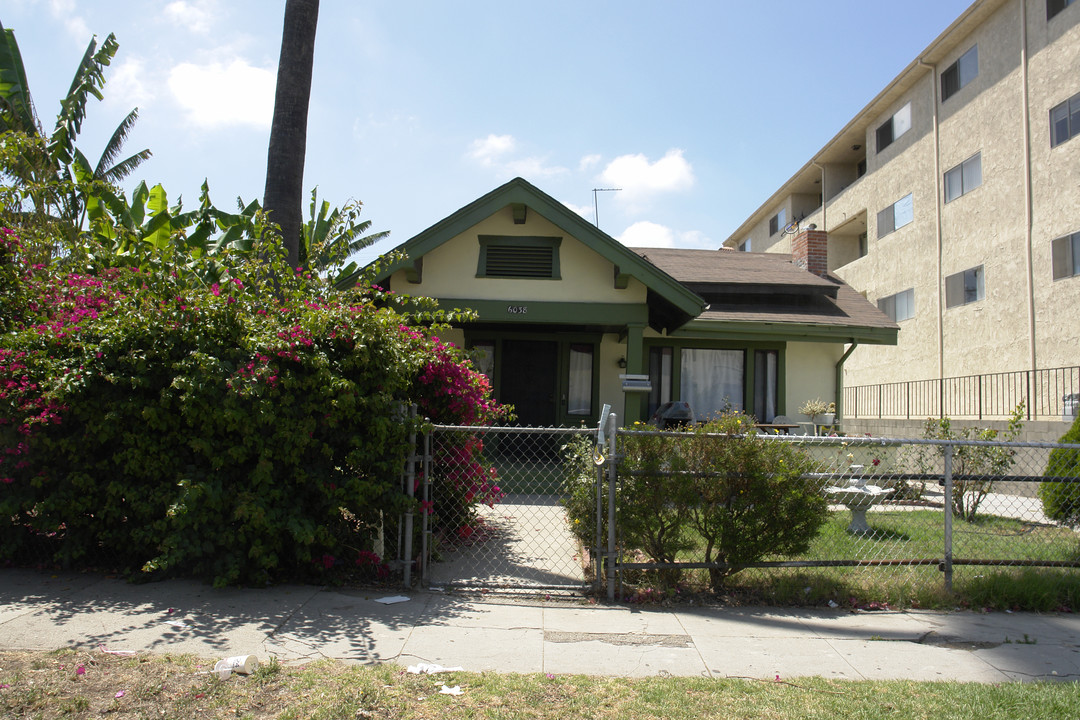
xmin=0 ymin=0 xmax=969 ymax=260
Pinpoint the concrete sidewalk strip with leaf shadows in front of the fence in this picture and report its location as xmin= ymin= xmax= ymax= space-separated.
xmin=0 ymin=569 xmax=1080 ymax=682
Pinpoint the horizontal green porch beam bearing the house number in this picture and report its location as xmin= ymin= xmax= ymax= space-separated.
xmin=438 ymin=298 xmax=649 ymax=327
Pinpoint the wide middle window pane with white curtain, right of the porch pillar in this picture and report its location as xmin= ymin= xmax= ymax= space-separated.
xmin=679 ymin=348 xmax=745 ymax=420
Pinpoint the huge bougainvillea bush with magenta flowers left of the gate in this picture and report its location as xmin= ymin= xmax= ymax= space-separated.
xmin=0 ymin=227 xmax=496 ymax=584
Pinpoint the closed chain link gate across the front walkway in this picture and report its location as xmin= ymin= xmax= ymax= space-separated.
xmin=415 ymin=425 xmax=597 ymax=590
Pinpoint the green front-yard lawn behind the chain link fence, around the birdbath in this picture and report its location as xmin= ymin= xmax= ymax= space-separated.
xmin=624 ymin=510 xmax=1080 ymax=612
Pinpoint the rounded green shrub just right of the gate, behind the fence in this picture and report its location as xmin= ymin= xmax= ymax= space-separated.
xmin=564 ymin=413 xmax=828 ymax=590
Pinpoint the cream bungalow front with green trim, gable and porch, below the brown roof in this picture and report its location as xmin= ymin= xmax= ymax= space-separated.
xmin=379 ymin=178 xmax=895 ymax=425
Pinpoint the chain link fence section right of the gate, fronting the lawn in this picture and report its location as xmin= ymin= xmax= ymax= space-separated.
xmin=602 ymin=430 xmax=1080 ymax=604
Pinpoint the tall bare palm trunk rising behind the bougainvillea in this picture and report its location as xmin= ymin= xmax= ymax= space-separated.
xmin=262 ymin=0 xmax=319 ymax=268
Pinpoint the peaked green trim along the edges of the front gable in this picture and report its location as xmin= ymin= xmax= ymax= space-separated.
xmin=377 ymin=177 xmax=705 ymax=324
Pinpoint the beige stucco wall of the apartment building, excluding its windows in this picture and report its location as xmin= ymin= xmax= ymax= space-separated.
xmin=754 ymin=0 xmax=1080 ymax=399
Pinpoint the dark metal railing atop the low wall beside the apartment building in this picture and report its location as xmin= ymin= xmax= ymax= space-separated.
xmin=843 ymin=366 xmax=1080 ymax=420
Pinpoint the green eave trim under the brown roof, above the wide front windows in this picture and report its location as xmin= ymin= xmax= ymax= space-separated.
xmin=670 ymin=320 xmax=899 ymax=345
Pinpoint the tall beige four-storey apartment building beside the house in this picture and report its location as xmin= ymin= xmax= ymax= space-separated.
xmin=725 ymin=0 xmax=1080 ymax=417
